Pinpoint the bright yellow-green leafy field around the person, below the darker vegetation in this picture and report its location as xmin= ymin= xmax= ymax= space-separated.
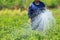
xmin=0 ymin=9 xmax=60 ymax=40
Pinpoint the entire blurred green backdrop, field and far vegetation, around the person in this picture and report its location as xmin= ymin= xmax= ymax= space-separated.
xmin=0 ymin=0 xmax=60 ymax=40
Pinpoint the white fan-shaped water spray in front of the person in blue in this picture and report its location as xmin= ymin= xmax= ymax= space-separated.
xmin=32 ymin=9 xmax=56 ymax=31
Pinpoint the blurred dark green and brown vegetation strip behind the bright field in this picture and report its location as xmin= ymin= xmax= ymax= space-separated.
xmin=0 ymin=0 xmax=60 ymax=9
